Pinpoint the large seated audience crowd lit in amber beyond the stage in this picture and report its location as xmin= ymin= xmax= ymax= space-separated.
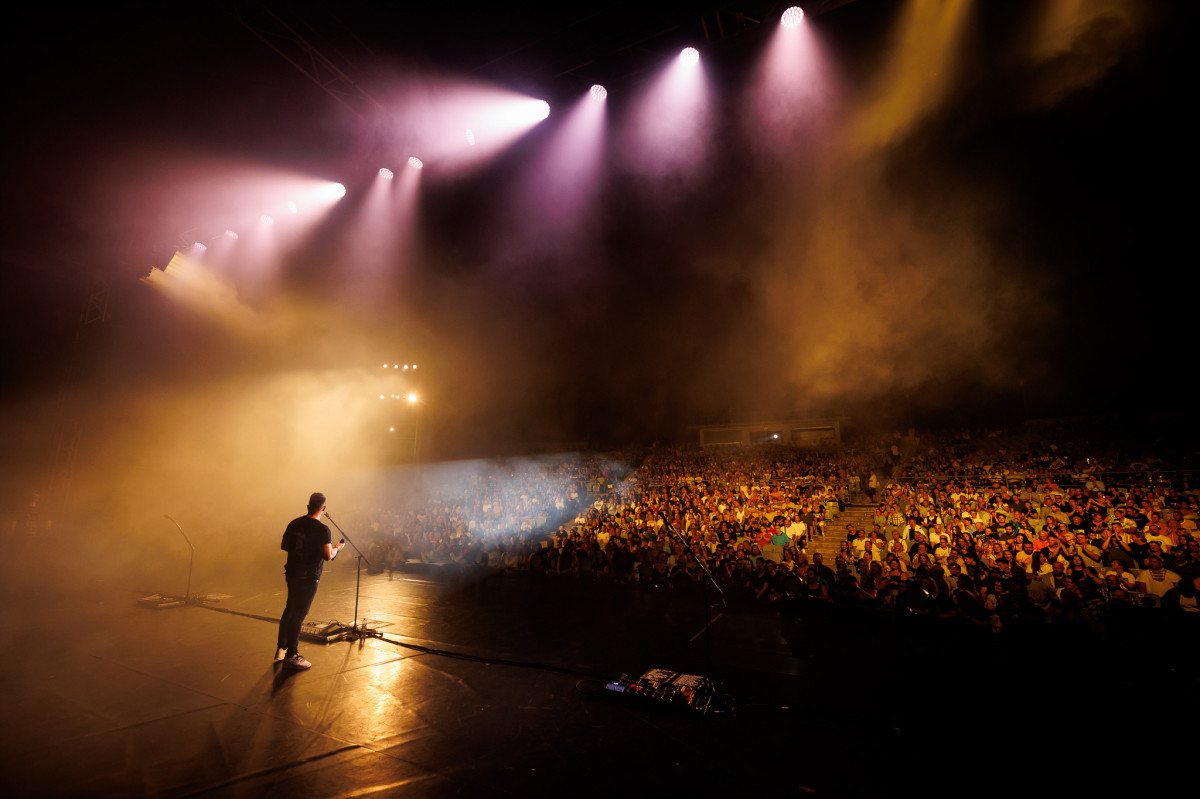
xmin=350 ymin=428 xmax=1200 ymax=635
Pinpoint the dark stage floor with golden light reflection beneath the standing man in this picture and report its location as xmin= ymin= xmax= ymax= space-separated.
xmin=0 ymin=560 xmax=1190 ymax=798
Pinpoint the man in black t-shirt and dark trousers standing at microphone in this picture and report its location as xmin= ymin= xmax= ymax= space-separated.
xmin=275 ymin=491 xmax=346 ymax=669
